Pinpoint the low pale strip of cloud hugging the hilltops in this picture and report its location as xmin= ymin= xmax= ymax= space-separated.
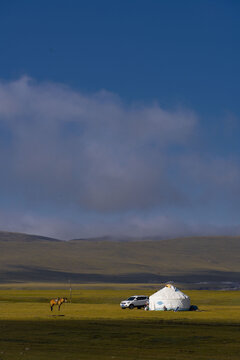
xmin=0 ymin=212 xmax=240 ymax=240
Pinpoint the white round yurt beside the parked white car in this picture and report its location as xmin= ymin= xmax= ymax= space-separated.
xmin=149 ymin=284 xmax=190 ymax=311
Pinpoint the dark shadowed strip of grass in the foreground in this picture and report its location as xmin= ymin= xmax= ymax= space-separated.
xmin=0 ymin=320 xmax=240 ymax=360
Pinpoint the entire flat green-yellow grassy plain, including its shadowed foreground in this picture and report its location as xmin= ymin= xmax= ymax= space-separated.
xmin=0 ymin=284 xmax=240 ymax=360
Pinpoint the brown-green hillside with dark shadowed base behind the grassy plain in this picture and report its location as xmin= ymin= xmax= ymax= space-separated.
xmin=0 ymin=232 xmax=240 ymax=282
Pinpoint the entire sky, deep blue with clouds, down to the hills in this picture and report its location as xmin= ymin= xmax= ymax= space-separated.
xmin=0 ymin=0 xmax=240 ymax=239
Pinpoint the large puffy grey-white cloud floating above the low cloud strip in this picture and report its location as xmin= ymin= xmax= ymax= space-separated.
xmin=0 ymin=77 xmax=196 ymax=211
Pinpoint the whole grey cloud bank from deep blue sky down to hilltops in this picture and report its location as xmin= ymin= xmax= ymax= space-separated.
xmin=0 ymin=77 xmax=240 ymax=237
